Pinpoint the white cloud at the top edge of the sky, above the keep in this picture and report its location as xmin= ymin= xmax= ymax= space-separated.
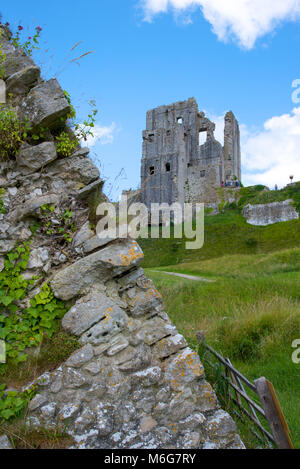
xmin=141 ymin=0 xmax=300 ymax=49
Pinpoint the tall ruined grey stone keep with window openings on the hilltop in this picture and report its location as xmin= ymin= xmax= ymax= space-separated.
xmin=141 ymin=98 xmax=241 ymax=208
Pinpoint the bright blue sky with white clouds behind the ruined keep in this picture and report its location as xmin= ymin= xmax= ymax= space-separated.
xmin=0 ymin=0 xmax=300 ymax=199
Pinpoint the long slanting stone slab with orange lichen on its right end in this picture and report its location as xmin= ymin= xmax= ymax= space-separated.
xmin=51 ymin=240 xmax=143 ymax=300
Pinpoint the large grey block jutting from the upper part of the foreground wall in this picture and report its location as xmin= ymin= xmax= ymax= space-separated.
xmin=22 ymin=78 xmax=70 ymax=129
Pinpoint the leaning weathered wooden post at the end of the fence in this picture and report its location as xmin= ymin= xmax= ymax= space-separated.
xmin=254 ymin=377 xmax=293 ymax=449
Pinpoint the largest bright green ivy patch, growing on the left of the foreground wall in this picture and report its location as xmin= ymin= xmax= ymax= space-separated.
xmin=0 ymin=243 xmax=66 ymax=368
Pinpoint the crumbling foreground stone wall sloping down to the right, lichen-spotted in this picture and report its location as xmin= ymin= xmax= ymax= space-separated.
xmin=0 ymin=26 xmax=243 ymax=449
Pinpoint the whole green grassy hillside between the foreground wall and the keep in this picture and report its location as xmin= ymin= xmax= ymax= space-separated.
xmin=140 ymin=204 xmax=300 ymax=448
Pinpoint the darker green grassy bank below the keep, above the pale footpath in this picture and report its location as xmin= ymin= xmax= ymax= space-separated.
xmin=139 ymin=209 xmax=300 ymax=267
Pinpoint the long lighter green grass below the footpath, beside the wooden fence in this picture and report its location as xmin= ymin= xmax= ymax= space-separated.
xmin=145 ymin=245 xmax=300 ymax=448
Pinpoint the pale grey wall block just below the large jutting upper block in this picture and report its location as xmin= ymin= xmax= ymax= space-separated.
xmin=17 ymin=142 xmax=57 ymax=174
